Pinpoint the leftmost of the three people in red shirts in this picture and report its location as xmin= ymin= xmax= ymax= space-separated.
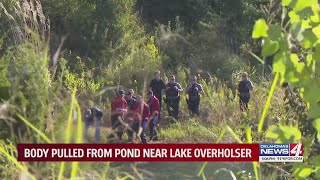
xmin=109 ymin=90 xmax=128 ymax=139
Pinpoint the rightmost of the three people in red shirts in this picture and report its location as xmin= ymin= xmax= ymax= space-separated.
xmin=147 ymin=90 xmax=160 ymax=141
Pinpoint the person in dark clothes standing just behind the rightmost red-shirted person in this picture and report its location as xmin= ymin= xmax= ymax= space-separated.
xmin=149 ymin=70 xmax=166 ymax=118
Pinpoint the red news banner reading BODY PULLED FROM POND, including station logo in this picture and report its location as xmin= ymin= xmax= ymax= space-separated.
xmin=18 ymin=144 xmax=303 ymax=162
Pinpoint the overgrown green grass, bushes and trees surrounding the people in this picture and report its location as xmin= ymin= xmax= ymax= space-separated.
xmin=0 ymin=0 xmax=320 ymax=179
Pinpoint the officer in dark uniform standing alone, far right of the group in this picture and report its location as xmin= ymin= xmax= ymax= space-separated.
xmin=238 ymin=72 xmax=253 ymax=111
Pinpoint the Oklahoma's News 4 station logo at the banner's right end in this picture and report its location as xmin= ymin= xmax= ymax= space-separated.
xmin=259 ymin=144 xmax=303 ymax=162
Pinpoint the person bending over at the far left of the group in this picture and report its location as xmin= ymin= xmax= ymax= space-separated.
xmin=84 ymin=107 xmax=103 ymax=143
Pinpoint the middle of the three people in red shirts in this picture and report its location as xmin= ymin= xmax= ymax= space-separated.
xmin=128 ymin=96 xmax=150 ymax=144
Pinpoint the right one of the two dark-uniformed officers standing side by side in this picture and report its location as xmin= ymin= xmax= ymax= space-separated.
xmin=186 ymin=76 xmax=204 ymax=116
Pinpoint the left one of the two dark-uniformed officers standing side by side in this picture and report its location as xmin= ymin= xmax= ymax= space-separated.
xmin=165 ymin=75 xmax=183 ymax=120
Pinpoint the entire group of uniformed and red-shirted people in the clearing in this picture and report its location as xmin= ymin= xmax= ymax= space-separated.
xmin=85 ymin=71 xmax=253 ymax=144
